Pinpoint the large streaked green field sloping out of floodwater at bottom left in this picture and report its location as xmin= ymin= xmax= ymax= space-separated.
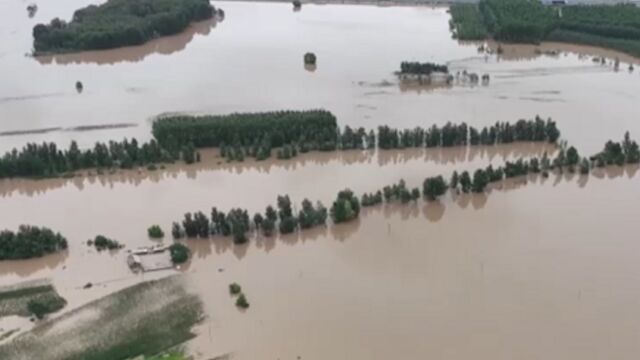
xmin=0 ymin=276 xmax=203 ymax=360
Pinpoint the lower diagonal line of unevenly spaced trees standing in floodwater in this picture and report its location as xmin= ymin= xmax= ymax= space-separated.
xmin=166 ymin=132 xmax=640 ymax=248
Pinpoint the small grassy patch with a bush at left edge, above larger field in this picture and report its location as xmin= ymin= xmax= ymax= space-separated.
xmin=0 ymin=283 xmax=67 ymax=319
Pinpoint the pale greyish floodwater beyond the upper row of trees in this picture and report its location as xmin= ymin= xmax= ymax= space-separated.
xmin=0 ymin=0 xmax=640 ymax=151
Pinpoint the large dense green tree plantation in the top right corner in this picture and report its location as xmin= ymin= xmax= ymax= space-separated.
xmin=450 ymin=0 xmax=640 ymax=55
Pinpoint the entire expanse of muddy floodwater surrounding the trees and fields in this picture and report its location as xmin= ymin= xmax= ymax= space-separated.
xmin=0 ymin=0 xmax=640 ymax=360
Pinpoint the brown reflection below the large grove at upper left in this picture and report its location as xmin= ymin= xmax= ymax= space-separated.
xmin=34 ymin=18 xmax=221 ymax=66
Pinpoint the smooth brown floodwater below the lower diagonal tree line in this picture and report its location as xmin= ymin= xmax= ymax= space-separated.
xmin=184 ymin=169 xmax=640 ymax=360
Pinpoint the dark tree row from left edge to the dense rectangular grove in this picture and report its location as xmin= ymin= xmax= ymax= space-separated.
xmin=0 ymin=138 xmax=199 ymax=178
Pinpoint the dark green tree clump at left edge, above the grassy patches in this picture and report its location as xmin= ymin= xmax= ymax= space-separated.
xmin=0 ymin=225 xmax=67 ymax=260
